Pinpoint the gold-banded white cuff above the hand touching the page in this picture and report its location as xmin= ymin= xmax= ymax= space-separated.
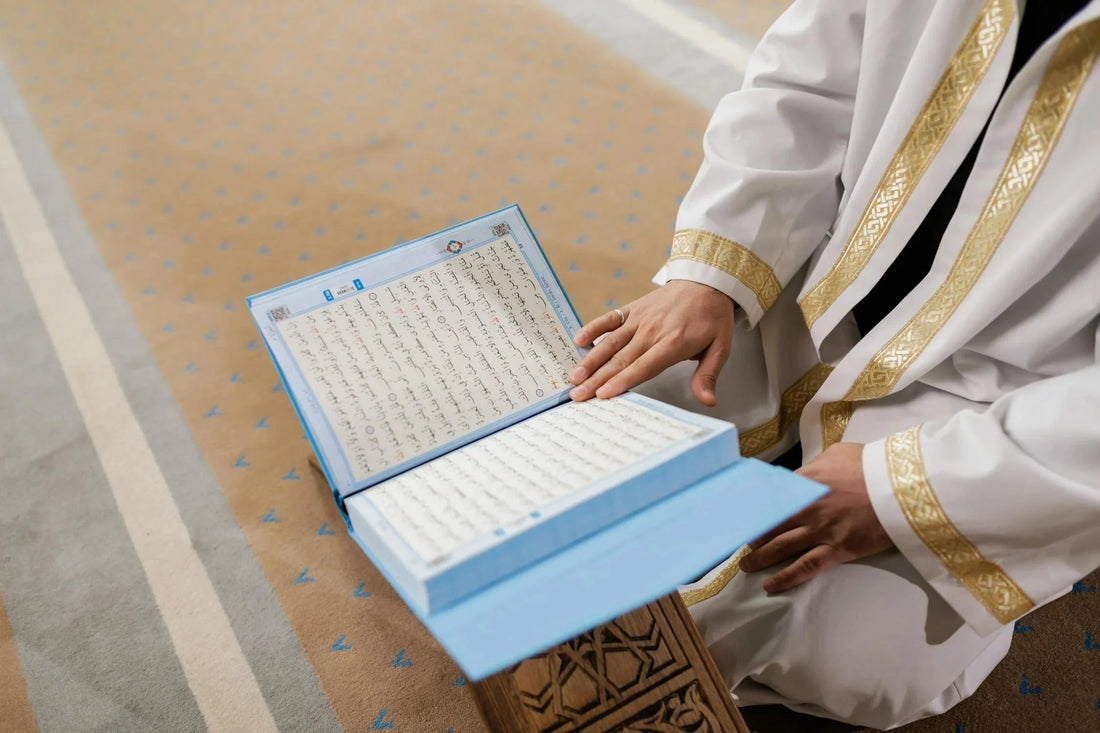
xmin=653 ymin=229 xmax=782 ymax=328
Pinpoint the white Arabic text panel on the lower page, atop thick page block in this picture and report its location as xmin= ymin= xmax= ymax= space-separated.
xmin=356 ymin=398 xmax=706 ymax=564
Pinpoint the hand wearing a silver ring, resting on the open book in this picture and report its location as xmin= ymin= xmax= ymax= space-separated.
xmin=569 ymin=280 xmax=734 ymax=407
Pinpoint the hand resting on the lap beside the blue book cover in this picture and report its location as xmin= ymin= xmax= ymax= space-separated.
xmin=740 ymin=442 xmax=894 ymax=593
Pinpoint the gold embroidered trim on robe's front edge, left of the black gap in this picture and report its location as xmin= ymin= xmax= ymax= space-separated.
xmin=799 ymin=0 xmax=1016 ymax=328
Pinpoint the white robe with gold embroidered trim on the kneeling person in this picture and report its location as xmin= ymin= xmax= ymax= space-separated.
xmin=646 ymin=0 xmax=1100 ymax=727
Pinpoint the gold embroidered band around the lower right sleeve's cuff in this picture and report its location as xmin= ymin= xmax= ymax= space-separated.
xmin=887 ymin=426 xmax=1035 ymax=624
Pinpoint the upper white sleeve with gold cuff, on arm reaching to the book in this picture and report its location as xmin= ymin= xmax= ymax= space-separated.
xmin=653 ymin=0 xmax=866 ymax=326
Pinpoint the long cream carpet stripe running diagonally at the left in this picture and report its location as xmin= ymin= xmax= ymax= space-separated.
xmin=0 ymin=117 xmax=276 ymax=731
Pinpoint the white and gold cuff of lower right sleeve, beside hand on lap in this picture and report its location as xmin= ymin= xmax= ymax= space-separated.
xmin=862 ymin=426 xmax=1005 ymax=636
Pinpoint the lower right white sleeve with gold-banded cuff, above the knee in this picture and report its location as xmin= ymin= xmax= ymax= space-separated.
xmin=864 ymin=358 xmax=1100 ymax=634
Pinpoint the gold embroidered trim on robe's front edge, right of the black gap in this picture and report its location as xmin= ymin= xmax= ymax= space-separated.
xmin=845 ymin=21 xmax=1100 ymax=400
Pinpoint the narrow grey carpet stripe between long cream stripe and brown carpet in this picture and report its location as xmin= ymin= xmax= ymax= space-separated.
xmin=0 ymin=58 xmax=340 ymax=731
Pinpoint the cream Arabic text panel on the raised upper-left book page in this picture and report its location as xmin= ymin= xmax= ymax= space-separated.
xmin=277 ymin=236 xmax=579 ymax=482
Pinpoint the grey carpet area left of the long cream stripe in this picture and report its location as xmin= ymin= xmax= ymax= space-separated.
xmin=0 ymin=215 xmax=205 ymax=731
